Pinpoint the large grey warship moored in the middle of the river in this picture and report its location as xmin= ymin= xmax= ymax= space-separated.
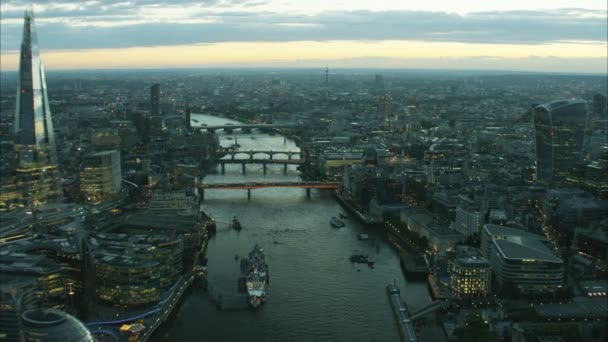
xmin=241 ymin=244 xmax=268 ymax=308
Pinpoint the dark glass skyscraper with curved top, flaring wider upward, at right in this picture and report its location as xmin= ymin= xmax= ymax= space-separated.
xmin=533 ymin=100 xmax=589 ymax=185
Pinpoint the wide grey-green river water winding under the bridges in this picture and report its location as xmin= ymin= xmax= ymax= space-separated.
xmin=154 ymin=114 xmax=443 ymax=342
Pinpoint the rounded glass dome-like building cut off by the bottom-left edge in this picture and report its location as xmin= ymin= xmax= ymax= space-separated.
xmin=21 ymin=308 xmax=95 ymax=342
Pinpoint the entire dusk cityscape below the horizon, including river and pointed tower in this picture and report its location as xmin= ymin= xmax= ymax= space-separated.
xmin=0 ymin=3 xmax=608 ymax=342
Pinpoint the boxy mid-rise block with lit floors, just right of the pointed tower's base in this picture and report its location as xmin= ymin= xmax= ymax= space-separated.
xmin=80 ymin=150 xmax=122 ymax=202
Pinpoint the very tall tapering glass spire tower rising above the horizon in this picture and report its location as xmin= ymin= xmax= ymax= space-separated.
xmin=14 ymin=9 xmax=60 ymax=206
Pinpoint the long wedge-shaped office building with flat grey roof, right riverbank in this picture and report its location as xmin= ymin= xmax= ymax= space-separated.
xmin=481 ymin=224 xmax=564 ymax=293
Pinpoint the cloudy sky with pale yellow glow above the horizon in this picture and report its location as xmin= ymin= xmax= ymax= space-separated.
xmin=0 ymin=0 xmax=608 ymax=73
